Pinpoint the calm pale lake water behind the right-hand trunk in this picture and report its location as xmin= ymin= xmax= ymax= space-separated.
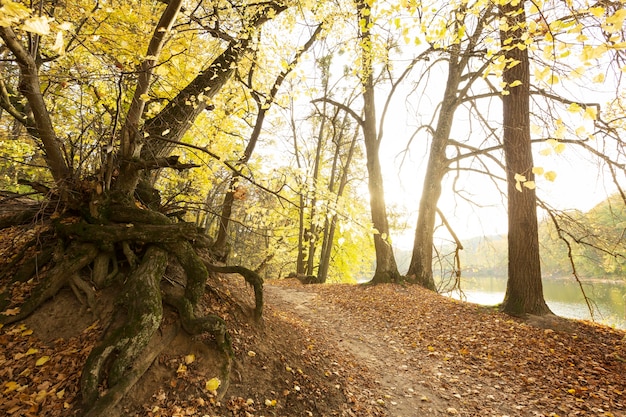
xmin=444 ymin=278 xmax=626 ymax=329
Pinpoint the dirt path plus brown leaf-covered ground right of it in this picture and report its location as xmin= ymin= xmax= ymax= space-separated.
xmin=268 ymin=284 xmax=626 ymax=417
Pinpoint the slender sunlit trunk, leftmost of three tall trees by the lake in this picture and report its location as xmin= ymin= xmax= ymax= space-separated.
xmin=357 ymin=1 xmax=400 ymax=283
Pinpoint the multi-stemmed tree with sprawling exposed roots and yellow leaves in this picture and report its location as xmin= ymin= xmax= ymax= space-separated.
xmin=0 ymin=0 xmax=287 ymax=416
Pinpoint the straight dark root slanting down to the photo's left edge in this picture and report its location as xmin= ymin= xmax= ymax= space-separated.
xmin=0 ymin=243 xmax=98 ymax=324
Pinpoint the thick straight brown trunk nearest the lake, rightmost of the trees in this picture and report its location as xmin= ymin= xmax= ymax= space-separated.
xmin=499 ymin=3 xmax=550 ymax=315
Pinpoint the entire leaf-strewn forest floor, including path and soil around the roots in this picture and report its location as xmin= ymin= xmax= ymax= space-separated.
xmin=0 ymin=276 xmax=626 ymax=417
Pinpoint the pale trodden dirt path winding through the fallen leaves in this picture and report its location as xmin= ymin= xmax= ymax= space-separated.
xmin=265 ymin=285 xmax=458 ymax=417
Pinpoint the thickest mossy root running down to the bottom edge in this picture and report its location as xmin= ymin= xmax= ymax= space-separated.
xmin=80 ymin=246 xmax=167 ymax=415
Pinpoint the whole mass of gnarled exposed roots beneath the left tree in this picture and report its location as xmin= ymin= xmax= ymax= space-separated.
xmin=0 ymin=202 xmax=263 ymax=417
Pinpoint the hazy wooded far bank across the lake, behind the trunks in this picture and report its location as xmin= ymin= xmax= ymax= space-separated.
xmin=414 ymin=194 xmax=626 ymax=279
